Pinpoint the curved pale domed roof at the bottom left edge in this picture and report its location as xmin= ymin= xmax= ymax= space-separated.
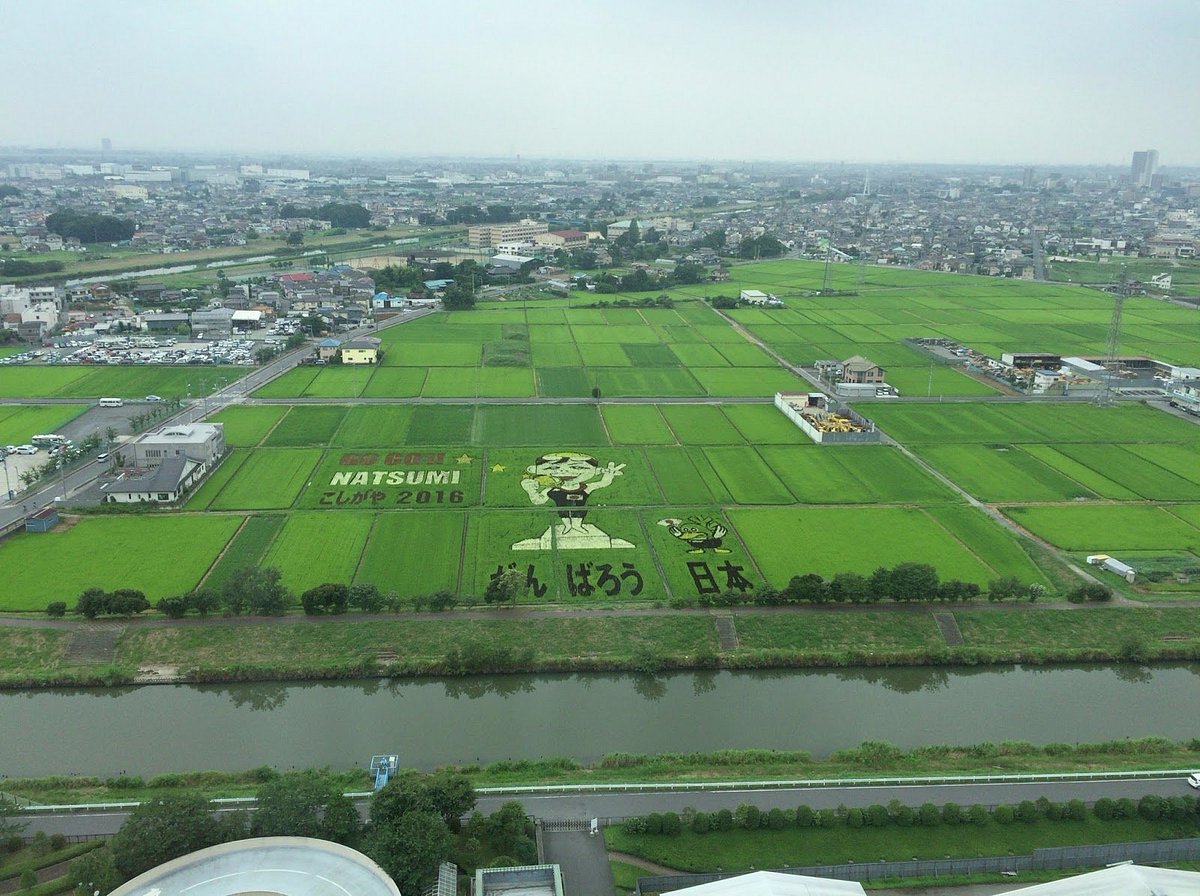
xmin=110 ymin=837 xmax=400 ymax=896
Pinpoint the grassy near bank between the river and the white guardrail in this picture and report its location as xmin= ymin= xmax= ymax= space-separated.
xmin=0 ymin=738 xmax=1200 ymax=805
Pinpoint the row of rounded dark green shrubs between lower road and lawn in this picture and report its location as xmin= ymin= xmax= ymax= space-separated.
xmin=622 ymin=795 xmax=1200 ymax=836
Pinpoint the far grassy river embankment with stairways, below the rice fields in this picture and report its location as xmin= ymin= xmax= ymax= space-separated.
xmin=0 ymin=605 xmax=1200 ymax=688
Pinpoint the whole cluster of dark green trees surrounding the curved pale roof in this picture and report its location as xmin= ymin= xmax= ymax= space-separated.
xmin=71 ymin=771 xmax=528 ymax=894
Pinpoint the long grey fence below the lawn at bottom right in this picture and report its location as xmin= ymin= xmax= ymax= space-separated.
xmin=637 ymin=837 xmax=1200 ymax=896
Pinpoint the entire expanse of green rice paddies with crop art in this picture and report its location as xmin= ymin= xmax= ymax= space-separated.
xmin=0 ymin=261 xmax=1200 ymax=609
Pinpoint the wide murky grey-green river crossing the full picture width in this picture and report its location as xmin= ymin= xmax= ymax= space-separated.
xmin=0 ymin=663 xmax=1200 ymax=776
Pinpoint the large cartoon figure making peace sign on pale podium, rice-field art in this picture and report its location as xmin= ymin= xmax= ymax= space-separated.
xmin=512 ymin=451 xmax=634 ymax=551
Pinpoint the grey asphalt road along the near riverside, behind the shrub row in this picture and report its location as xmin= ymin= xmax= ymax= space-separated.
xmin=23 ymin=777 xmax=1194 ymax=836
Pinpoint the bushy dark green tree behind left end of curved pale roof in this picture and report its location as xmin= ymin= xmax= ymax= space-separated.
xmin=112 ymin=794 xmax=221 ymax=878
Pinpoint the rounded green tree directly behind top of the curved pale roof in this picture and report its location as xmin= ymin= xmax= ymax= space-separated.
xmin=251 ymin=770 xmax=360 ymax=847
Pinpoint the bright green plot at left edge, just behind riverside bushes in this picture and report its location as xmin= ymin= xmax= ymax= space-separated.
xmin=0 ymin=513 xmax=241 ymax=609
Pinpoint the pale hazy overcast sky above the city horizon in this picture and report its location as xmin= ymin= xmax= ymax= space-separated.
xmin=0 ymin=0 xmax=1200 ymax=166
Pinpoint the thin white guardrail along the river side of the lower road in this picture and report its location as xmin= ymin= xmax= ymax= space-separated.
xmin=20 ymin=768 xmax=1195 ymax=814
